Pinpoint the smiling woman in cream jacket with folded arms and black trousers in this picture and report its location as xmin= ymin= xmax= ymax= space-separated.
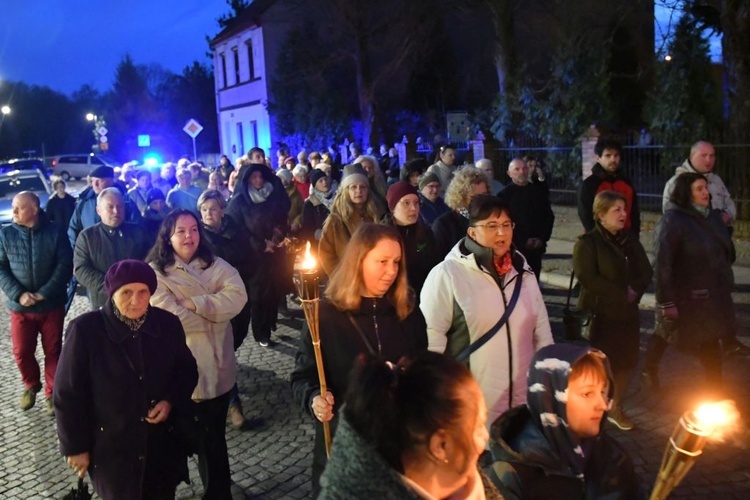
xmin=147 ymin=210 xmax=247 ymax=499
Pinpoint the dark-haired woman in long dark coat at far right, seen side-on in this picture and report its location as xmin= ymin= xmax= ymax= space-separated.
xmin=644 ymin=173 xmax=735 ymax=389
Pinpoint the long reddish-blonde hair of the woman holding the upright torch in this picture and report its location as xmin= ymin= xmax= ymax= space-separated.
xmin=325 ymin=223 xmax=415 ymax=320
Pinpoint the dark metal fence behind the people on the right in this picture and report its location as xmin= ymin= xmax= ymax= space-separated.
xmin=491 ymin=144 xmax=750 ymax=220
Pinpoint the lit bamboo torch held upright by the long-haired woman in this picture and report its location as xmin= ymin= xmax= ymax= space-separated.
xmin=294 ymin=241 xmax=331 ymax=456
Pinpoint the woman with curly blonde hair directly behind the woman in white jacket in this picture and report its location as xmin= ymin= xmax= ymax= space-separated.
xmin=432 ymin=166 xmax=490 ymax=257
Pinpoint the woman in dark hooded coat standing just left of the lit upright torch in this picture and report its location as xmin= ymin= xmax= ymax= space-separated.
xmin=226 ymin=164 xmax=291 ymax=347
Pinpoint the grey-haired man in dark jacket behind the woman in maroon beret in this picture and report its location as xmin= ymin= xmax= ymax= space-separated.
xmin=73 ymin=187 xmax=149 ymax=310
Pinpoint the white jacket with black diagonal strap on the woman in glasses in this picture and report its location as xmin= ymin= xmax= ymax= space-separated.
xmin=420 ymin=238 xmax=553 ymax=426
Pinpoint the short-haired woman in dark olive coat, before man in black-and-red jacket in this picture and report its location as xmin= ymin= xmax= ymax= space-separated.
xmin=573 ymin=191 xmax=652 ymax=431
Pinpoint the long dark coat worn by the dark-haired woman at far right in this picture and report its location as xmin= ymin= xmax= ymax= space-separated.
xmin=654 ymin=205 xmax=734 ymax=349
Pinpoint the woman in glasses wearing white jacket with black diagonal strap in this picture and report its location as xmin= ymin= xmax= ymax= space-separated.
xmin=420 ymin=195 xmax=552 ymax=422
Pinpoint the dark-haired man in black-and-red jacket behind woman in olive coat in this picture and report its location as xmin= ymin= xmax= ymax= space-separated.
xmin=578 ymin=137 xmax=641 ymax=237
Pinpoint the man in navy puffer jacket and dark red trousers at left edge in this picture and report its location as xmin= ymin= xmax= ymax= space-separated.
xmin=0 ymin=191 xmax=73 ymax=414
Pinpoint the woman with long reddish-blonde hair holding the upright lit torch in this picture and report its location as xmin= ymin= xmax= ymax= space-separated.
xmin=291 ymin=224 xmax=427 ymax=496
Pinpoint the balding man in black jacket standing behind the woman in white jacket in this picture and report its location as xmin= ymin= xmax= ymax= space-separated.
xmin=498 ymin=158 xmax=555 ymax=280
